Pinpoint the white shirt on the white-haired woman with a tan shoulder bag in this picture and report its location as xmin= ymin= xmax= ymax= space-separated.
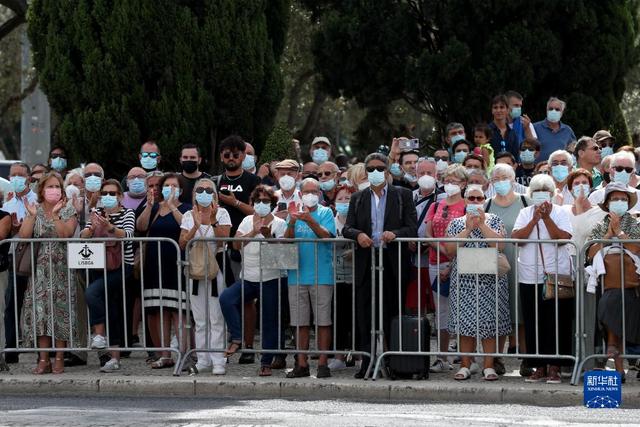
xmin=513 ymin=205 xmax=573 ymax=284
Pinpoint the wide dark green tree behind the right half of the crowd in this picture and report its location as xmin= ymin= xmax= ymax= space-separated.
xmin=305 ymin=0 xmax=638 ymax=145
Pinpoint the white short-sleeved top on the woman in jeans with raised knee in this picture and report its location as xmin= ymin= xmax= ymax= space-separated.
xmin=238 ymin=215 xmax=287 ymax=282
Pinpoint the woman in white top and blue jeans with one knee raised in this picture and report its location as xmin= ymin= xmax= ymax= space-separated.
xmin=220 ymin=184 xmax=287 ymax=377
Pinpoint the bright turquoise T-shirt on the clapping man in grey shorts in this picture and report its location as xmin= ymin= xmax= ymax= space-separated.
xmin=289 ymin=205 xmax=336 ymax=285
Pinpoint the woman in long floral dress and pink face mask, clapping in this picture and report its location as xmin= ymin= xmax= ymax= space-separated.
xmin=18 ymin=172 xmax=78 ymax=375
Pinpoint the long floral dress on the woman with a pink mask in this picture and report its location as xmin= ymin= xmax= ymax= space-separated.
xmin=22 ymin=206 xmax=78 ymax=347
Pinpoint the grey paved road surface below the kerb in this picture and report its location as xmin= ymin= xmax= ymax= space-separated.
xmin=0 ymin=397 xmax=640 ymax=427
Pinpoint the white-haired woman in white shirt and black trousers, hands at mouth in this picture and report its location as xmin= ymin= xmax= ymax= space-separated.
xmin=511 ymin=175 xmax=574 ymax=384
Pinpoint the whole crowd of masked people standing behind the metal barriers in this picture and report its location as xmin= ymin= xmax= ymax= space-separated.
xmin=0 ymin=92 xmax=640 ymax=383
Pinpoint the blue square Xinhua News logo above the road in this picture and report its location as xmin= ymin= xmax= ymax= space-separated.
xmin=584 ymin=371 xmax=622 ymax=408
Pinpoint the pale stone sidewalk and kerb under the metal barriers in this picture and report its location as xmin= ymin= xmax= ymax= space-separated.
xmin=0 ymin=352 xmax=640 ymax=408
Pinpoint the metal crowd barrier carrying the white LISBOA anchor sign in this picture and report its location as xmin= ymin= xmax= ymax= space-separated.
xmin=0 ymin=237 xmax=184 ymax=372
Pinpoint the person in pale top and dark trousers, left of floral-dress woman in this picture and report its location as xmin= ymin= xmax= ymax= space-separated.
xmin=2 ymin=162 xmax=38 ymax=363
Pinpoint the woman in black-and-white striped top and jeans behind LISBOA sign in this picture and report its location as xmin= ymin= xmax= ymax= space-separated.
xmin=80 ymin=179 xmax=135 ymax=373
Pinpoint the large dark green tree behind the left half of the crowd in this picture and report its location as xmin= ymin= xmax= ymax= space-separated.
xmin=29 ymin=0 xmax=289 ymax=173
